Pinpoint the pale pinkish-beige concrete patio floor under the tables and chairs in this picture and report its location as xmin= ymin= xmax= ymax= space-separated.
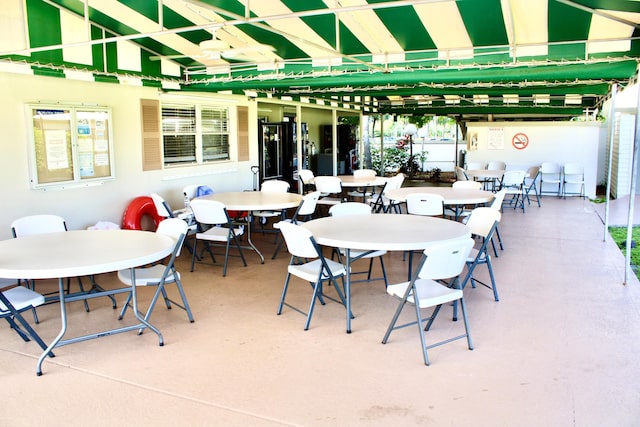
xmin=0 ymin=197 xmax=640 ymax=427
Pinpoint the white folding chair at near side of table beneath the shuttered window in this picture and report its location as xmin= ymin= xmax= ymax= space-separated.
xmin=191 ymin=198 xmax=247 ymax=277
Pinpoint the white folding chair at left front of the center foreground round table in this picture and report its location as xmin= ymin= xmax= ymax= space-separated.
xmin=277 ymin=222 xmax=347 ymax=331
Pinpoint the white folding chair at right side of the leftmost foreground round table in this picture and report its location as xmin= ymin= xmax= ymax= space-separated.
xmin=118 ymin=218 xmax=193 ymax=326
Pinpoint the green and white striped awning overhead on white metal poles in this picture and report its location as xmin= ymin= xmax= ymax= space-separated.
xmin=0 ymin=0 xmax=640 ymax=116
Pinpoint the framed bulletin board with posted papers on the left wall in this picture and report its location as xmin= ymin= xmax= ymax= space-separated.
xmin=27 ymin=104 xmax=114 ymax=188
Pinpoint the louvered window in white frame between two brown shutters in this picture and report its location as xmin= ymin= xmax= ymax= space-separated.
xmin=162 ymin=104 xmax=229 ymax=166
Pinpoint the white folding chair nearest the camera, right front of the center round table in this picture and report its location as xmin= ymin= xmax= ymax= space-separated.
xmin=382 ymin=239 xmax=473 ymax=365
